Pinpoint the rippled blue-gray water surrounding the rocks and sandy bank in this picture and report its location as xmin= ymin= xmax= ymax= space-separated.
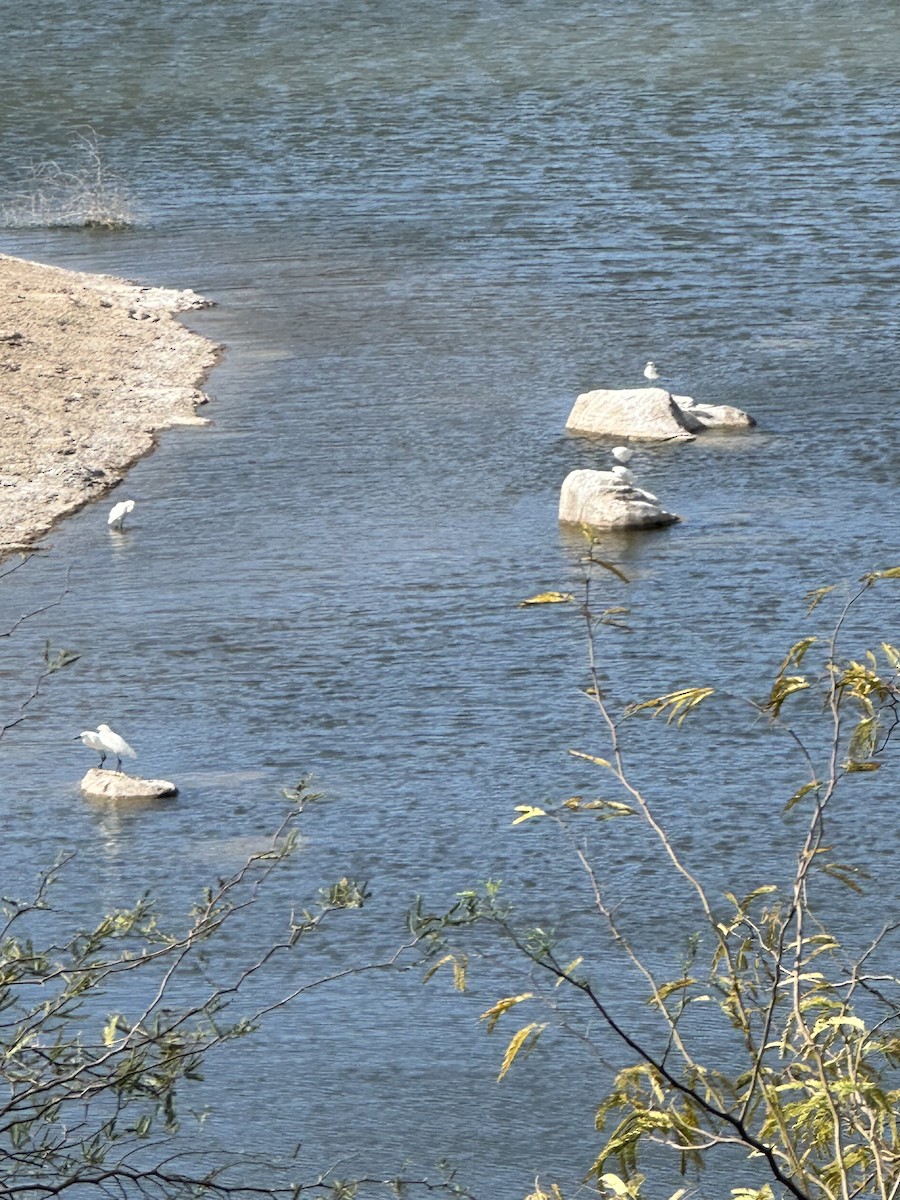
xmin=0 ymin=0 xmax=900 ymax=1200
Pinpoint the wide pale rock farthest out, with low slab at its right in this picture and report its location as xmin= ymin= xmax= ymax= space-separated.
xmin=565 ymin=388 xmax=756 ymax=442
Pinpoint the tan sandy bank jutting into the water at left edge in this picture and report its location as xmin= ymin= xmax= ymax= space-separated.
xmin=0 ymin=254 xmax=221 ymax=558
